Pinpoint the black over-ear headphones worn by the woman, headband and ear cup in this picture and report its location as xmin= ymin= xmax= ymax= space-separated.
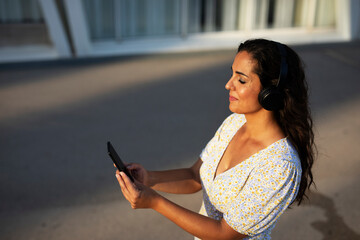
xmin=258 ymin=42 xmax=288 ymax=111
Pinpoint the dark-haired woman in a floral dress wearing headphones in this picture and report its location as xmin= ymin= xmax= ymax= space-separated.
xmin=116 ymin=39 xmax=314 ymax=239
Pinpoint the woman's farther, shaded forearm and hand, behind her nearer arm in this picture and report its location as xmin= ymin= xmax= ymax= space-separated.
xmin=128 ymin=158 xmax=202 ymax=194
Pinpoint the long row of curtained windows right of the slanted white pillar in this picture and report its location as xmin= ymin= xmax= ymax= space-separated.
xmin=83 ymin=0 xmax=335 ymax=41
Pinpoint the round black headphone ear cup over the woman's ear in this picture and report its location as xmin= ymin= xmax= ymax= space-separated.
xmin=258 ymin=87 xmax=284 ymax=111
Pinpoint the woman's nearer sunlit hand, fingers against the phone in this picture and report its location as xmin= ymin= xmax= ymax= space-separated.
xmin=115 ymin=170 xmax=160 ymax=209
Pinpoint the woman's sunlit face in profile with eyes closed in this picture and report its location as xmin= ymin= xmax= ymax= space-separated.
xmin=225 ymin=51 xmax=262 ymax=114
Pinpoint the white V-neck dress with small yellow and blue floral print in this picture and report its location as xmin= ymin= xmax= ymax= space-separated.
xmin=195 ymin=113 xmax=301 ymax=239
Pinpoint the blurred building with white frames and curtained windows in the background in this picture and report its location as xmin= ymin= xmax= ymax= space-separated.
xmin=0 ymin=0 xmax=360 ymax=62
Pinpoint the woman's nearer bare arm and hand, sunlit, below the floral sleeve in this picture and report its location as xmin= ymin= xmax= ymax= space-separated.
xmin=116 ymin=171 xmax=246 ymax=240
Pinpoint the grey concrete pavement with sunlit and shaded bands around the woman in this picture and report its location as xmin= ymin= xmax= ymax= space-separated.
xmin=0 ymin=42 xmax=360 ymax=240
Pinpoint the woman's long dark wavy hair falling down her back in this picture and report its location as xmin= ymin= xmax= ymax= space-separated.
xmin=238 ymin=39 xmax=316 ymax=205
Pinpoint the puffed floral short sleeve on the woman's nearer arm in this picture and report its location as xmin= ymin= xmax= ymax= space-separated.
xmin=224 ymin=159 xmax=301 ymax=236
